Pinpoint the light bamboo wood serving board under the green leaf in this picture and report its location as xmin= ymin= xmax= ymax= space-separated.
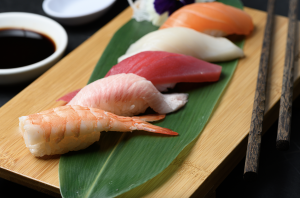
xmin=0 ymin=8 xmax=300 ymax=197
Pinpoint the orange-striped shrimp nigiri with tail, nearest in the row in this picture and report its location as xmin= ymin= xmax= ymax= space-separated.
xmin=19 ymin=105 xmax=178 ymax=157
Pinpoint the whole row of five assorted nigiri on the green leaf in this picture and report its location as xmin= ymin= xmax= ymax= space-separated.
xmin=19 ymin=0 xmax=253 ymax=156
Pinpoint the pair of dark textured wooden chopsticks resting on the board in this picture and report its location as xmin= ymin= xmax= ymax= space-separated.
xmin=244 ymin=0 xmax=297 ymax=181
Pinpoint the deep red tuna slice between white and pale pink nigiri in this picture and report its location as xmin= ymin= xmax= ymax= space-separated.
xmin=105 ymin=51 xmax=222 ymax=85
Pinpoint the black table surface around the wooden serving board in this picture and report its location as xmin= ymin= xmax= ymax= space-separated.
xmin=0 ymin=0 xmax=300 ymax=198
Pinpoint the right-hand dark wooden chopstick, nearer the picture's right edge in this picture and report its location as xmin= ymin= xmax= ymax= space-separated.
xmin=276 ymin=0 xmax=297 ymax=151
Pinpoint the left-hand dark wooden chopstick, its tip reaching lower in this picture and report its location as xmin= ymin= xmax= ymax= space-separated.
xmin=244 ymin=0 xmax=275 ymax=181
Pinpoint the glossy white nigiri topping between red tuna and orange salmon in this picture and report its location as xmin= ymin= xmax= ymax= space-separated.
xmin=118 ymin=27 xmax=244 ymax=62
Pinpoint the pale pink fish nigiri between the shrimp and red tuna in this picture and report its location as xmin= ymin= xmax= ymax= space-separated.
xmin=68 ymin=74 xmax=188 ymax=116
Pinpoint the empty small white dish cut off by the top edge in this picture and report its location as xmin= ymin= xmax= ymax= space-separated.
xmin=43 ymin=0 xmax=115 ymax=26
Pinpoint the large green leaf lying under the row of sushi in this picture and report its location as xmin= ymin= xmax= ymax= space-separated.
xmin=59 ymin=0 xmax=243 ymax=198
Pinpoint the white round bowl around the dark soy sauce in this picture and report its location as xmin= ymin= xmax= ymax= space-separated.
xmin=0 ymin=12 xmax=68 ymax=85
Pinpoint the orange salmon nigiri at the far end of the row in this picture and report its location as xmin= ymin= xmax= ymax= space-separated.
xmin=160 ymin=2 xmax=253 ymax=36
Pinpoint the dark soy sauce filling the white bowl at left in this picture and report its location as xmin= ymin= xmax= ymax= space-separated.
xmin=0 ymin=28 xmax=55 ymax=69
